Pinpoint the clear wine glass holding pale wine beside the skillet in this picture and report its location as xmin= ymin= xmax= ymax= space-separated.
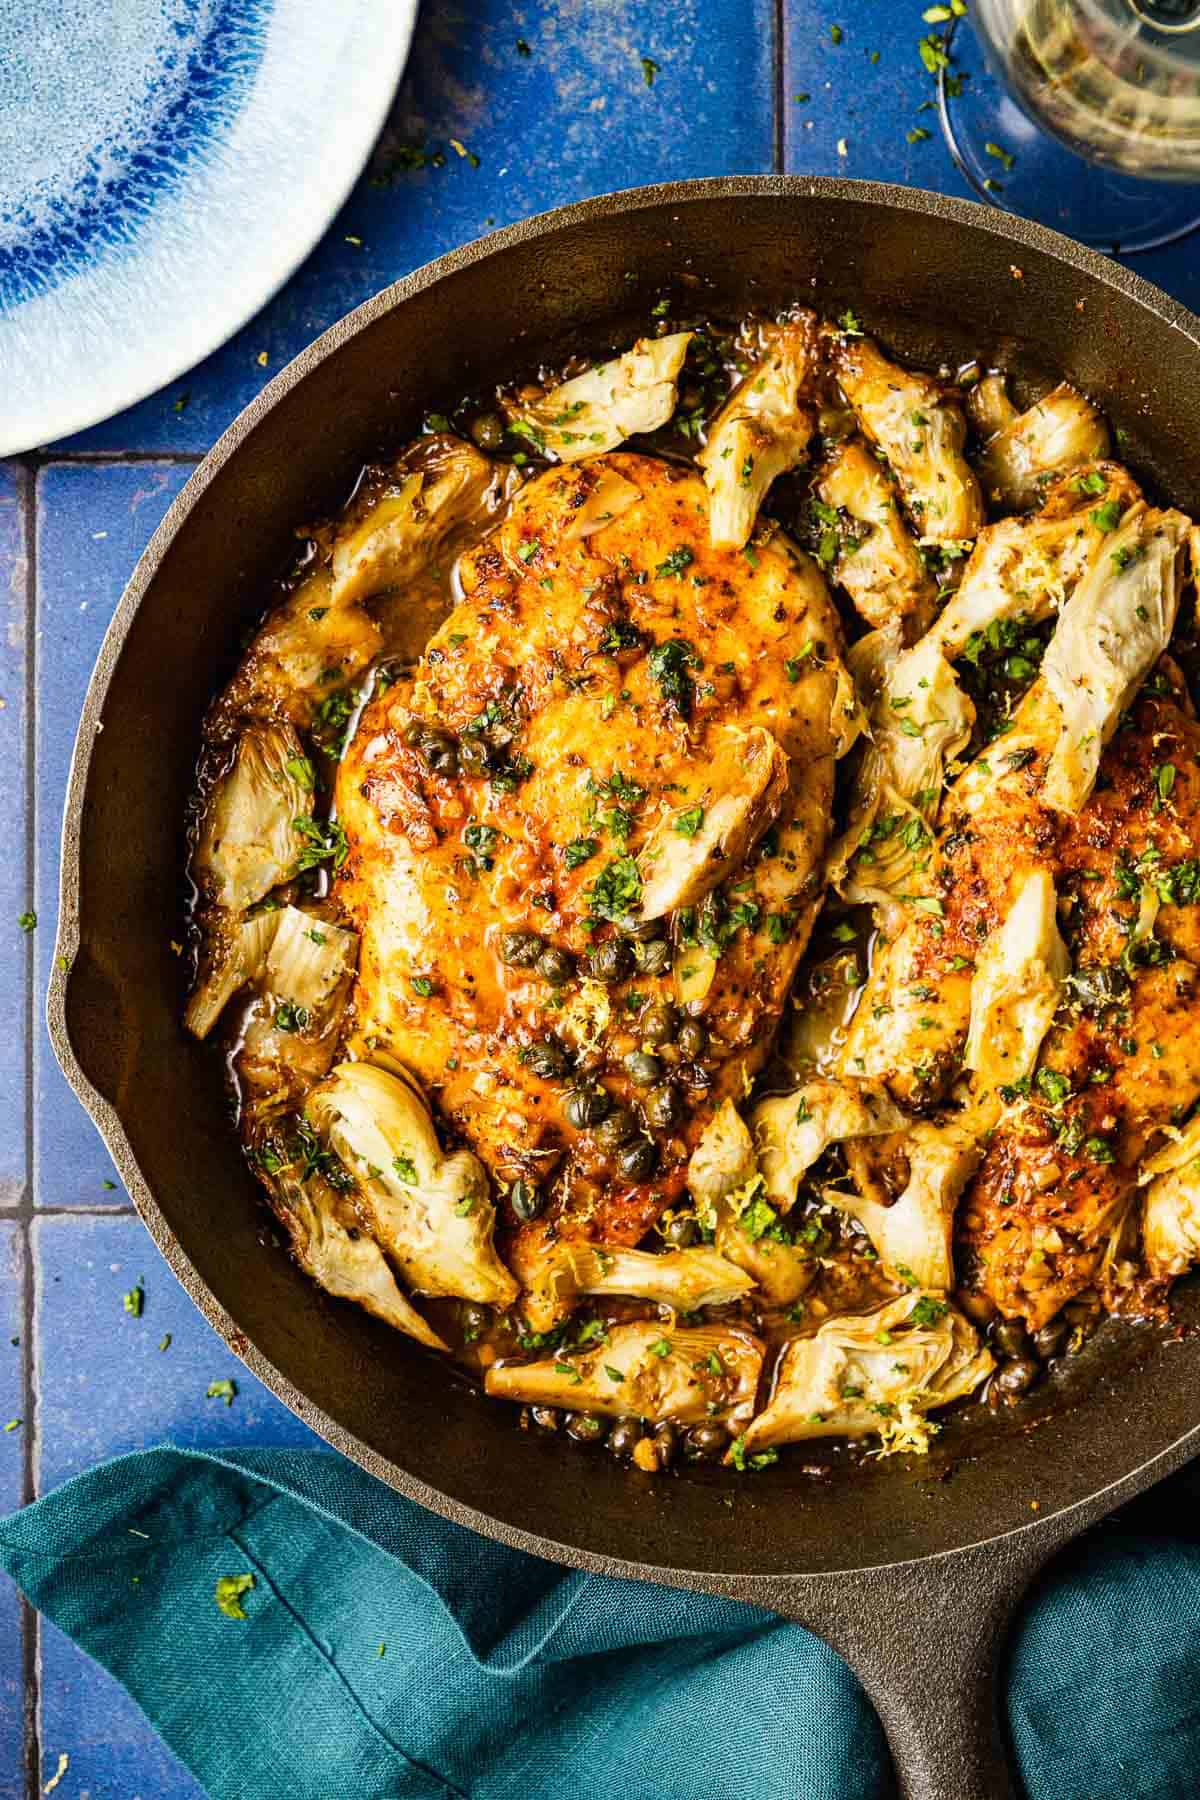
xmin=925 ymin=0 xmax=1200 ymax=256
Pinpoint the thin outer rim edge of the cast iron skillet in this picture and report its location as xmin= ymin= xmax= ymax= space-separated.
xmin=47 ymin=175 xmax=1200 ymax=1576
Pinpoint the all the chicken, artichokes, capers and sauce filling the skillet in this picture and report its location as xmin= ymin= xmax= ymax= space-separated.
xmin=189 ymin=311 xmax=1200 ymax=1469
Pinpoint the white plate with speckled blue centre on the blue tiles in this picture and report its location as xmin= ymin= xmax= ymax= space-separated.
xmin=0 ymin=0 xmax=417 ymax=455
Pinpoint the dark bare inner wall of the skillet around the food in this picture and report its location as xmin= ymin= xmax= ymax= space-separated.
xmin=67 ymin=184 xmax=1200 ymax=1575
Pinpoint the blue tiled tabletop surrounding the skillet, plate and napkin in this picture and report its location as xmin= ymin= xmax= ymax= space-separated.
xmin=0 ymin=0 xmax=1200 ymax=1800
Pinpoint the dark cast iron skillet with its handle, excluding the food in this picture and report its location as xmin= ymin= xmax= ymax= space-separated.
xmin=49 ymin=176 xmax=1200 ymax=1800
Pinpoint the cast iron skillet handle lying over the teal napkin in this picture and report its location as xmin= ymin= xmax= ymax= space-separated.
xmin=772 ymin=1532 xmax=1058 ymax=1800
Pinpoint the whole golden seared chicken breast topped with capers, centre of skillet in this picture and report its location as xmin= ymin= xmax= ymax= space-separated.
xmin=336 ymin=454 xmax=855 ymax=1296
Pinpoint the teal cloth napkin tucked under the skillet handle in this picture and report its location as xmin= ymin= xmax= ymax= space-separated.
xmin=0 ymin=1447 xmax=1200 ymax=1800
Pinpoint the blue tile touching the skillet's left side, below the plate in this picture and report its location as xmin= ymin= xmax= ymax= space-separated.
xmin=32 ymin=463 xmax=191 ymax=1206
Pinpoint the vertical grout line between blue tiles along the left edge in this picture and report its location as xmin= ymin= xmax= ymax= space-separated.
xmin=18 ymin=459 xmax=41 ymax=1800
